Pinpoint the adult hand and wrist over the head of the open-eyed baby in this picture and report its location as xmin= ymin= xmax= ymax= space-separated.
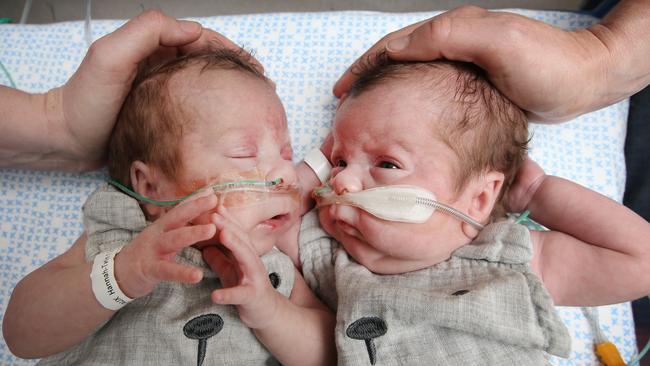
xmin=334 ymin=1 xmax=650 ymax=122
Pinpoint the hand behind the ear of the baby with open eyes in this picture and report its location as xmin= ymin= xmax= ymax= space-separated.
xmin=506 ymin=157 xmax=546 ymax=212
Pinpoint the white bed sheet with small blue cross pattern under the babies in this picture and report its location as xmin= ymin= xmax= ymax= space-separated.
xmin=0 ymin=10 xmax=637 ymax=365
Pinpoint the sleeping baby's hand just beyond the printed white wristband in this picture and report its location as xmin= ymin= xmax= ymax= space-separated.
xmin=115 ymin=195 xmax=217 ymax=298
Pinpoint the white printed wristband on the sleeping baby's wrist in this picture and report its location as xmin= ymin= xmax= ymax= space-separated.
xmin=90 ymin=248 xmax=133 ymax=310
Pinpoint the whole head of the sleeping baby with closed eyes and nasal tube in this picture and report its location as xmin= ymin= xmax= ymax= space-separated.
xmin=108 ymin=49 xmax=297 ymax=252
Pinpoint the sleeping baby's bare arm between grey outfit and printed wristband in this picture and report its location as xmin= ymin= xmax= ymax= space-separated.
xmin=2 ymin=263 xmax=113 ymax=358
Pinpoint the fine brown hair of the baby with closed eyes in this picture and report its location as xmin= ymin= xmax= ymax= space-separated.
xmin=108 ymin=47 xmax=270 ymax=188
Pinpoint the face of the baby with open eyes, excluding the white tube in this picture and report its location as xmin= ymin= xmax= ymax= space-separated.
xmin=319 ymin=83 xmax=471 ymax=274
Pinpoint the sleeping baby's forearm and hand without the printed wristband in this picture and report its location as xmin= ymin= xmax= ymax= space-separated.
xmin=203 ymin=207 xmax=336 ymax=365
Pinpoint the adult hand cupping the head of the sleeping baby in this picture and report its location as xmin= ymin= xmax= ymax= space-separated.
xmin=55 ymin=11 xmax=261 ymax=170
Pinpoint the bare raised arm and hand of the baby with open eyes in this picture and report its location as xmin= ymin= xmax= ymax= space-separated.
xmin=509 ymin=160 xmax=650 ymax=306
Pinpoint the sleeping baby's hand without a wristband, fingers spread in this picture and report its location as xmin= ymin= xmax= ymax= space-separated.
xmin=203 ymin=206 xmax=279 ymax=329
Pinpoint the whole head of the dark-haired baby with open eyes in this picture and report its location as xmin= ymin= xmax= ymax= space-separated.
xmin=320 ymin=57 xmax=528 ymax=273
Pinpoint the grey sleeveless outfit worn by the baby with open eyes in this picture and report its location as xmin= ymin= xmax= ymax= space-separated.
xmin=300 ymin=212 xmax=571 ymax=365
